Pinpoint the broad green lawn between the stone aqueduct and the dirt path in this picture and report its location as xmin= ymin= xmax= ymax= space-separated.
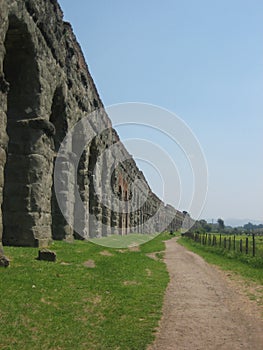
xmin=0 ymin=233 xmax=170 ymax=350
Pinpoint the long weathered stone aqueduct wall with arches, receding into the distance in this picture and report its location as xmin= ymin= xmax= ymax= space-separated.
xmin=0 ymin=0 xmax=184 ymax=246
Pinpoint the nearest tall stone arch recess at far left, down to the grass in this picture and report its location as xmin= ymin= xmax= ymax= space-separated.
xmin=2 ymin=16 xmax=45 ymax=246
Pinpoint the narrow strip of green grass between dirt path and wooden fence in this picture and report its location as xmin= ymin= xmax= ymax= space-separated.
xmin=178 ymin=238 xmax=263 ymax=284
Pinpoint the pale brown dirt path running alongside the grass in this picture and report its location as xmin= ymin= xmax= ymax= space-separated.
xmin=148 ymin=238 xmax=263 ymax=350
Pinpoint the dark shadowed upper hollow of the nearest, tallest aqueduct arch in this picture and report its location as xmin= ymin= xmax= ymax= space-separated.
xmin=4 ymin=16 xmax=40 ymax=120
